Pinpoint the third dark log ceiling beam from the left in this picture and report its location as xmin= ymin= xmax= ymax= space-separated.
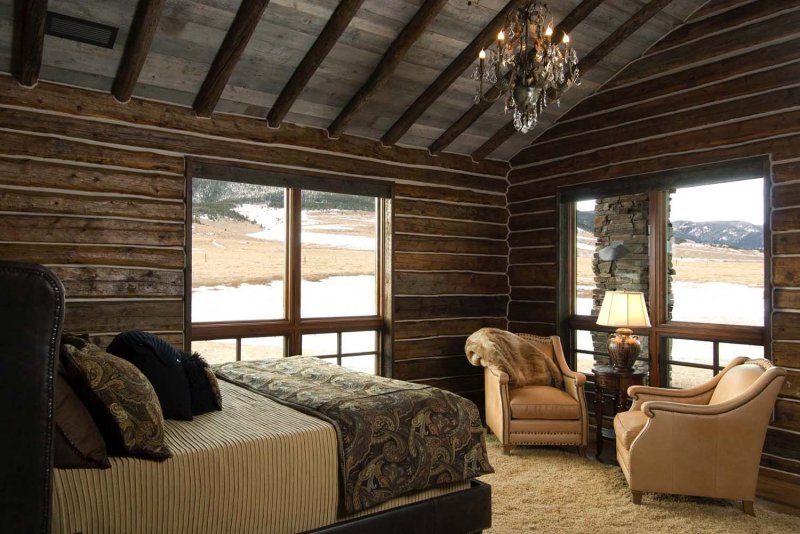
xmin=192 ymin=0 xmax=269 ymax=117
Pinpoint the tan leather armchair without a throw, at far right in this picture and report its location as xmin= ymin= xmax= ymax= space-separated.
xmin=614 ymin=357 xmax=786 ymax=515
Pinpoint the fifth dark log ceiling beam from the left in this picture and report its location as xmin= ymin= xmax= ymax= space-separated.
xmin=328 ymin=0 xmax=447 ymax=139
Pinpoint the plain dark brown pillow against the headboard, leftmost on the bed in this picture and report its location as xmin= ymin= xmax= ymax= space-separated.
xmin=53 ymin=362 xmax=111 ymax=469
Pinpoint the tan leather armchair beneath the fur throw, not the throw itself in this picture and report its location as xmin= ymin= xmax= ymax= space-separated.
xmin=483 ymin=334 xmax=589 ymax=456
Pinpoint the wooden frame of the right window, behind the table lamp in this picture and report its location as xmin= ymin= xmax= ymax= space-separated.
xmin=557 ymin=157 xmax=772 ymax=386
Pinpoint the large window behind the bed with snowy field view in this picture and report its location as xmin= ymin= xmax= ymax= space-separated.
xmin=189 ymin=164 xmax=390 ymax=373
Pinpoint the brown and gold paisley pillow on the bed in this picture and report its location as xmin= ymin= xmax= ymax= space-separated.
xmin=61 ymin=343 xmax=172 ymax=460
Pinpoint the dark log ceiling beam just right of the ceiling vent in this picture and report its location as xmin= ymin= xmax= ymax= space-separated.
xmin=111 ymin=0 xmax=164 ymax=102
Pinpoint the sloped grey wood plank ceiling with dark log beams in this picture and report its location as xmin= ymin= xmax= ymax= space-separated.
xmin=0 ymin=0 xmax=715 ymax=160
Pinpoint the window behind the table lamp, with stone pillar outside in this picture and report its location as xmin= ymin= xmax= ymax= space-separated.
xmin=562 ymin=162 xmax=767 ymax=388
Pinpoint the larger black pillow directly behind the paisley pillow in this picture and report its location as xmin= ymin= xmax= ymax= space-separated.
xmin=106 ymin=330 xmax=192 ymax=421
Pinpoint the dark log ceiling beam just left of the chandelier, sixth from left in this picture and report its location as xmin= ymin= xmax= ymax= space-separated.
xmin=381 ymin=0 xmax=530 ymax=146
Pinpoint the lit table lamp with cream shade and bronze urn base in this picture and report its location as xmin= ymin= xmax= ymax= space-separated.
xmin=597 ymin=291 xmax=650 ymax=372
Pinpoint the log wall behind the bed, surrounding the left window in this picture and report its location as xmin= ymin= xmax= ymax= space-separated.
xmin=0 ymin=71 xmax=508 ymax=404
